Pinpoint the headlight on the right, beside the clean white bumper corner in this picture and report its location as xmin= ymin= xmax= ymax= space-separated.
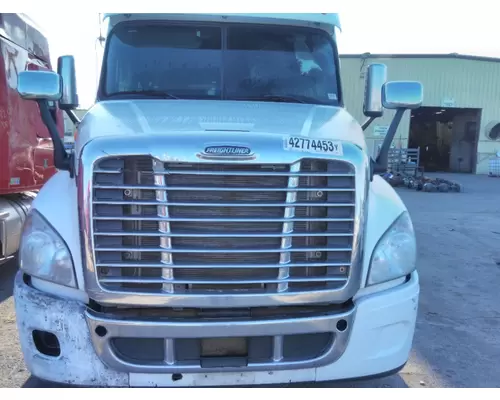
xmin=367 ymin=211 xmax=417 ymax=285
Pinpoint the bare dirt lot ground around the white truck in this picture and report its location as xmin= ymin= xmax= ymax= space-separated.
xmin=0 ymin=175 xmax=500 ymax=387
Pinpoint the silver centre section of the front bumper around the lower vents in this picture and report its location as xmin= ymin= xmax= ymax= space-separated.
xmin=85 ymin=307 xmax=355 ymax=373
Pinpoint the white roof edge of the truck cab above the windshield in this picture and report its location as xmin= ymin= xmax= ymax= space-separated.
xmin=103 ymin=13 xmax=341 ymax=34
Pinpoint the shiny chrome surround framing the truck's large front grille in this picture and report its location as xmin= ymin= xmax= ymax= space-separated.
xmin=77 ymin=132 xmax=369 ymax=308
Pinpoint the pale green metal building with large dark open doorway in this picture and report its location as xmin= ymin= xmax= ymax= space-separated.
xmin=341 ymin=54 xmax=500 ymax=174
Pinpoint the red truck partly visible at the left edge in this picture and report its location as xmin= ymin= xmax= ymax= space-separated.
xmin=0 ymin=13 xmax=64 ymax=265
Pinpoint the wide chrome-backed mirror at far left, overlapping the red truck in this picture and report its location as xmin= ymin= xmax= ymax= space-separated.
xmin=17 ymin=71 xmax=62 ymax=101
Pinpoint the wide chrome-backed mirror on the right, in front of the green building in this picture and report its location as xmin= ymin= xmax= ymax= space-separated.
xmin=382 ymin=81 xmax=424 ymax=110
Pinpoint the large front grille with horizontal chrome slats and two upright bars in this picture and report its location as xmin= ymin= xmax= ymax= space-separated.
xmin=92 ymin=156 xmax=355 ymax=295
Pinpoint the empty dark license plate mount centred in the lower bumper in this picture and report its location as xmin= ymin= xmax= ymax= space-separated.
xmin=200 ymin=337 xmax=248 ymax=368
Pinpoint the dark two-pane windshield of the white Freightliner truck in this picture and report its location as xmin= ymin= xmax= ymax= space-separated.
xmin=99 ymin=24 xmax=339 ymax=105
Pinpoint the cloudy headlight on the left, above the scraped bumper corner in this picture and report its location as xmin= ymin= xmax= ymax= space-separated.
xmin=19 ymin=210 xmax=76 ymax=287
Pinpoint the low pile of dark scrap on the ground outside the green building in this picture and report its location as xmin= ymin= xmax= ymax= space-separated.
xmin=381 ymin=172 xmax=463 ymax=193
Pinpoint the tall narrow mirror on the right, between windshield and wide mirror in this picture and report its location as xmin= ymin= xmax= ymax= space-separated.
xmin=363 ymin=64 xmax=387 ymax=118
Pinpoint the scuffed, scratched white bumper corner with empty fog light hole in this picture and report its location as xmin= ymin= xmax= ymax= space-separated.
xmin=14 ymin=273 xmax=129 ymax=387
